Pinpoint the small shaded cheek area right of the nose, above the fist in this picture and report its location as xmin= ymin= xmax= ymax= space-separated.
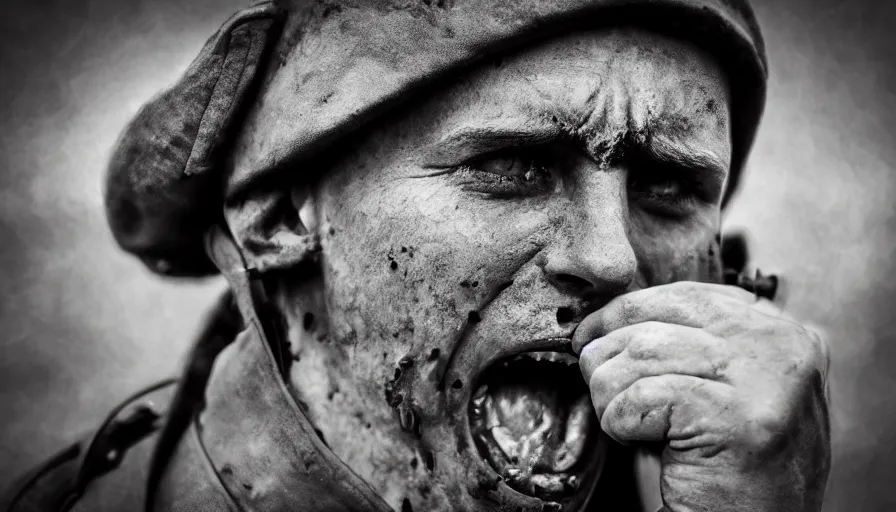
xmin=631 ymin=212 xmax=719 ymax=287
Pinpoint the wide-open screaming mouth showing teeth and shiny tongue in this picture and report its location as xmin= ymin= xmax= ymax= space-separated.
xmin=470 ymin=352 xmax=600 ymax=501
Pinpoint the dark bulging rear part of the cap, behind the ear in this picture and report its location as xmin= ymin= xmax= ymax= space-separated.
xmin=106 ymin=2 xmax=282 ymax=276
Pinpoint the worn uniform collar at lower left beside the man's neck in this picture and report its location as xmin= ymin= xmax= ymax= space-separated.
xmin=196 ymin=327 xmax=391 ymax=512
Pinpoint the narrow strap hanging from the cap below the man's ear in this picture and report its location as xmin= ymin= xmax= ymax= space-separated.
xmin=205 ymin=225 xmax=292 ymax=377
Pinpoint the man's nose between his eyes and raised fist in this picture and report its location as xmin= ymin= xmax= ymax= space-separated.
xmin=544 ymin=169 xmax=638 ymax=298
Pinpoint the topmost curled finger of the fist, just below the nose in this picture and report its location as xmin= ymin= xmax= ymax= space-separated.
xmin=572 ymin=281 xmax=756 ymax=344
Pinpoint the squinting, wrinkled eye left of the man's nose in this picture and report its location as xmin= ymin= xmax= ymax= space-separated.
xmin=457 ymin=150 xmax=551 ymax=197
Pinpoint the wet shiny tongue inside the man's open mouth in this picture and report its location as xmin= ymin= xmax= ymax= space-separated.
xmin=482 ymin=383 xmax=593 ymax=476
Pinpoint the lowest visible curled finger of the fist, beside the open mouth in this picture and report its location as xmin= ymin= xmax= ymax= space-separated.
xmin=600 ymin=374 xmax=737 ymax=449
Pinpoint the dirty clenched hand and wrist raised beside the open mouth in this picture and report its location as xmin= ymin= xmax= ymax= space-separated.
xmin=573 ymin=282 xmax=830 ymax=512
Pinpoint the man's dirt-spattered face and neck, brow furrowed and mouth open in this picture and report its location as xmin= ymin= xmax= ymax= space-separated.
xmin=280 ymin=29 xmax=731 ymax=510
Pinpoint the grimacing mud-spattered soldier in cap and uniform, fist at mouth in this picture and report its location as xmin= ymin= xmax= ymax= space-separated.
xmin=6 ymin=0 xmax=830 ymax=512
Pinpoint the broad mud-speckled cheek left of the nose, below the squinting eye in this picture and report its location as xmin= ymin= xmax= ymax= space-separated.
xmin=318 ymin=179 xmax=550 ymax=382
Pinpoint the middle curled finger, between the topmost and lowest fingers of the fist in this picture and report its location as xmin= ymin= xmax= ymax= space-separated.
xmin=579 ymin=323 xmax=731 ymax=417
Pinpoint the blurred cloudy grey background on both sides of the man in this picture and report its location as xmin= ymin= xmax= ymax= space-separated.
xmin=0 ymin=0 xmax=896 ymax=511
